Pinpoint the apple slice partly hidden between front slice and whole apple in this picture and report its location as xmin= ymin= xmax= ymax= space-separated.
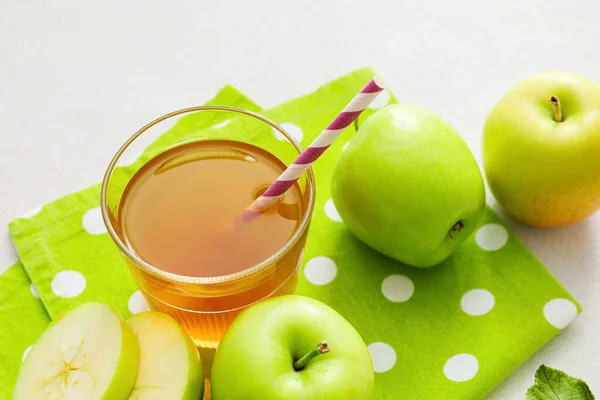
xmin=127 ymin=311 xmax=204 ymax=400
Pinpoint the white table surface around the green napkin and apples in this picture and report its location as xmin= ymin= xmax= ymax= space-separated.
xmin=0 ymin=0 xmax=600 ymax=400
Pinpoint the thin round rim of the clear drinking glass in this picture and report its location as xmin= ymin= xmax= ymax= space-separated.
xmin=100 ymin=106 xmax=316 ymax=285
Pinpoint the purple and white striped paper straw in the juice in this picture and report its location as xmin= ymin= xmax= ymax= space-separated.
xmin=242 ymin=76 xmax=384 ymax=221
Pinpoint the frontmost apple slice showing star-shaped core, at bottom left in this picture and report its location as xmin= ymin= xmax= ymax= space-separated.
xmin=13 ymin=303 xmax=139 ymax=400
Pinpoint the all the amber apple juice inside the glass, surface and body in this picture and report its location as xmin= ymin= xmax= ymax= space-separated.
xmin=115 ymin=140 xmax=307 ymax=349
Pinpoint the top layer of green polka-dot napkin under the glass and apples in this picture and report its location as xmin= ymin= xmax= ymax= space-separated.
xmin=2 ymin=68 xmax=580 ymax=400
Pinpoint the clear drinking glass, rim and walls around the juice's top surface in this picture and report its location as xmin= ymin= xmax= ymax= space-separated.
xmin=101 ymin=106 xmax=315 ymax=362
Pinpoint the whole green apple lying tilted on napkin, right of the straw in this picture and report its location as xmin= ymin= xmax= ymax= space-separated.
xmin=332 ymin=104 xmax=485 ymax=267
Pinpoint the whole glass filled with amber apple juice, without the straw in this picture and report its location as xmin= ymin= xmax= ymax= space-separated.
xmin=101 ymin=106 xmax=315 ymax=362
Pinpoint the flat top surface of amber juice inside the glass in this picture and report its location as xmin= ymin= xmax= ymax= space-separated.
xmin=119 ymin=140 xmax=302 ymax=277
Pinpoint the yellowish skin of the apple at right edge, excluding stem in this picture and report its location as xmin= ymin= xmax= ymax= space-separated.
xmin=483 ymin=71 xmax=600 ymax=227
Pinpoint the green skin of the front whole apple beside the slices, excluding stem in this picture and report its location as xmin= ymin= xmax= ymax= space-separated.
xmin=211 ymin=295 xmax=374 ymax=400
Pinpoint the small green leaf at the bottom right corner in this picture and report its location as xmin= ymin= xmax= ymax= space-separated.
xmin=527 ymin=365 xmax=594 ymax=400
